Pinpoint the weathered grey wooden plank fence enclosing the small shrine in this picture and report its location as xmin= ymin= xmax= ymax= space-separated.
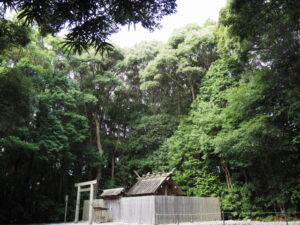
xmin=83 ymin=196 xmax=221 ymax=224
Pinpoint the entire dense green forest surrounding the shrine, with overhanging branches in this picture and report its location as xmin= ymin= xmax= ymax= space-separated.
xmin=0 ymin=0 xmax=300 ymax=224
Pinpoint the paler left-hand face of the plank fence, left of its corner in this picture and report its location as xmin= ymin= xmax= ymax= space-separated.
xmin=120 ymin=196 xmax=155 ymax=224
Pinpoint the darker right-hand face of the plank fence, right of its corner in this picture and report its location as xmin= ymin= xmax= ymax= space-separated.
xmin=155 ymin=196 xmax=221 ymax=224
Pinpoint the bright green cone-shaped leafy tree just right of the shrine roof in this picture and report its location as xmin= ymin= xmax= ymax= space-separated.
xmin=164 ymin=59 xmax=236 ymax=200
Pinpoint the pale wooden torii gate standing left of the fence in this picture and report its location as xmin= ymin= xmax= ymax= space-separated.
xmin=75 ymin=180 xmax=97 ymax=224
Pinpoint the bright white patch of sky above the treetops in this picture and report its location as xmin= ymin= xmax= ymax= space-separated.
xmin=110 ymin=0 xmax=226 ymax=48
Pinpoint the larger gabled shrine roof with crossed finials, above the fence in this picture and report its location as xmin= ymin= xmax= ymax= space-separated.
xmin=127 ymin=172 xmax=183 ymax=195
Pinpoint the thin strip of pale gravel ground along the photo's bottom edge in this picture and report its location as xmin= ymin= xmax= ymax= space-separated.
xmin=35 ymin=220 xmax=300 ymax=225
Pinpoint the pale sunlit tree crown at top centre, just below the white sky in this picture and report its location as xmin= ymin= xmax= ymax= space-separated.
xmin=140 ymin=23 xmax=217 ymax=115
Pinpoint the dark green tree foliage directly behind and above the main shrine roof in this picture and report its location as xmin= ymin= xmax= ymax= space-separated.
xmin=117 ymin=114 xmax=177 ymax=187
